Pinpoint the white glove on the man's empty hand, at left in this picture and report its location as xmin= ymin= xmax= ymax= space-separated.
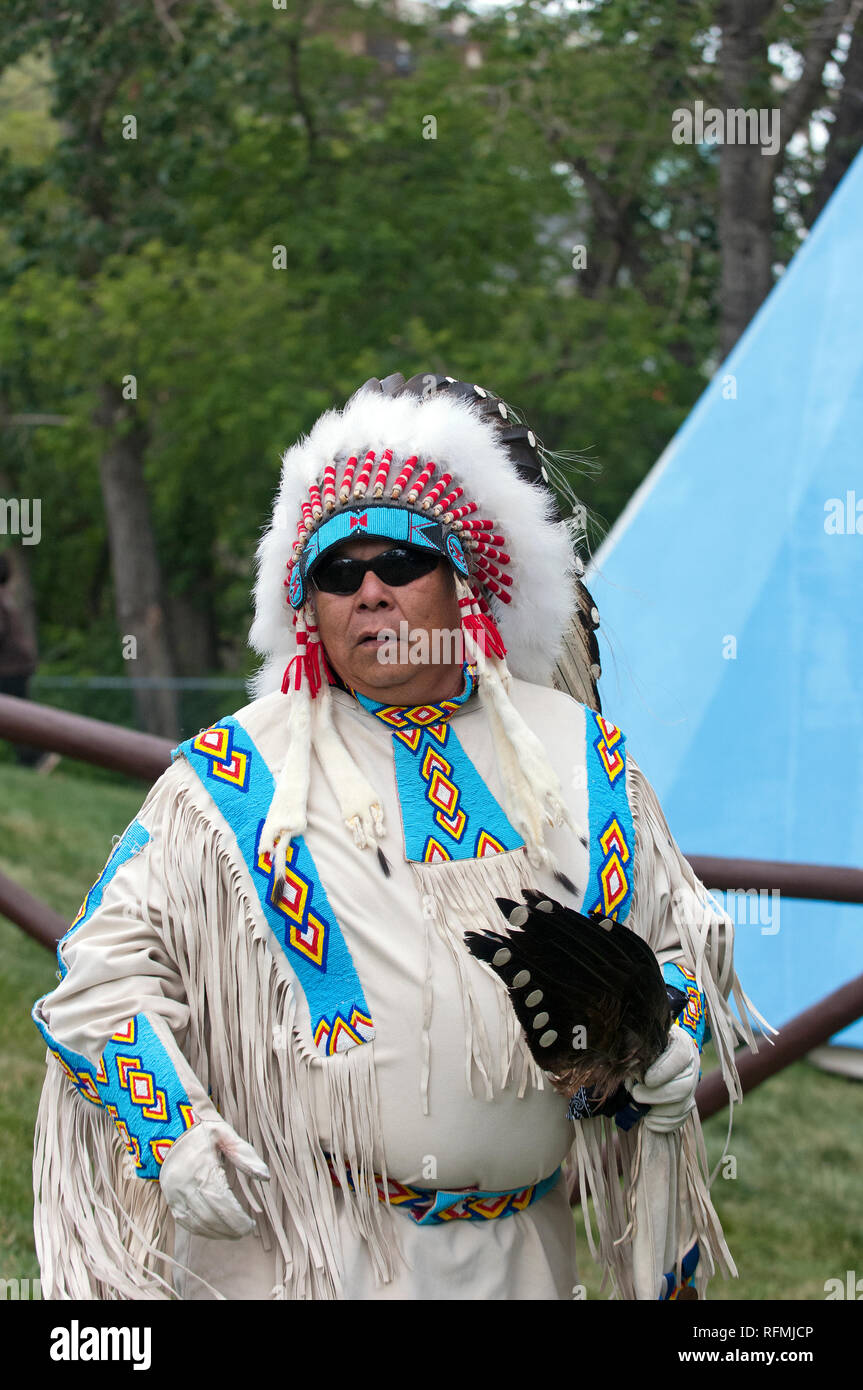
xmin=158 ymin=1120 xmax=270 ymax=1240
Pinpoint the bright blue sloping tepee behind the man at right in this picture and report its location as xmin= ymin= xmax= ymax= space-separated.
xmin=586 ymin=146 xmax=863 ymax=1047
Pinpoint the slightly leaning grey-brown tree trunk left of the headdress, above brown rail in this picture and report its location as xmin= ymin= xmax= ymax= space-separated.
xmin=94 ymin=385 xmax=179 ymax=738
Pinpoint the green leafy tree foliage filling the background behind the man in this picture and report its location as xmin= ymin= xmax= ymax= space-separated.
xmin=0 ymin=0 xmax=850 ymax=692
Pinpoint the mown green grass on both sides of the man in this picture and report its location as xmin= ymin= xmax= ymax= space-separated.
xmin=0 ymin=765 xmax=863 ymax=1301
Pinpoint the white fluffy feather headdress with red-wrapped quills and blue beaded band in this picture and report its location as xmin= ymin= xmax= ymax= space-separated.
xmin=250 ymin=375 xmax=599 ymax=873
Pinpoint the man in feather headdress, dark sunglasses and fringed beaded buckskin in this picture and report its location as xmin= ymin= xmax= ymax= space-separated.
xmin=33 ymin=377 xmax=752 ymax=1298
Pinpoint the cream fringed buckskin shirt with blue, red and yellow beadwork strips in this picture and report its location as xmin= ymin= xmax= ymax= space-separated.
xmin=33 ymin=666 xmax=750 ymax=1300
